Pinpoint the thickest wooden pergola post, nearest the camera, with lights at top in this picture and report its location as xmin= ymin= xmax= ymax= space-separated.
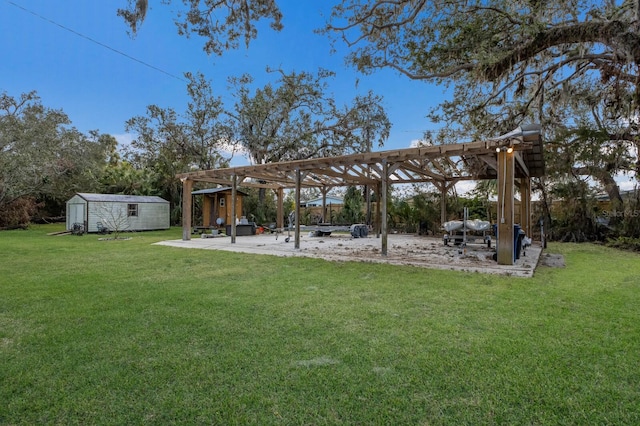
xmin=497 ymin=150 xmax=515 ymax=265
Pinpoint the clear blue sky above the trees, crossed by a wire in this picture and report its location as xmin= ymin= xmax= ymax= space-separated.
xmin=0 ymin=0 xmax=445 ymax=164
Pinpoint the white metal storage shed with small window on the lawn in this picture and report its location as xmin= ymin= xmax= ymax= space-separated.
xmin=67 ymin=193 xmax=169 ymax=232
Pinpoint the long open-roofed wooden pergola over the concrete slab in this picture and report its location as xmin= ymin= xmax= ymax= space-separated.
xmin=177 ymin=124 xmax=544 ymax=265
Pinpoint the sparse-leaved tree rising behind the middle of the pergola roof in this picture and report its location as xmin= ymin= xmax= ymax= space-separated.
xmin=229 ymin=70 xmax=391 ymax=164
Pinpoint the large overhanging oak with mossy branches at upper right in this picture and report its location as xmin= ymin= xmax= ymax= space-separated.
xmin=323 ymin=0 xmax=640 ymax=233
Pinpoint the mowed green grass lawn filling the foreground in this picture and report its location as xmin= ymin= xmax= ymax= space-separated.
xmin=0 ymin=225 xmax=640 ymax=425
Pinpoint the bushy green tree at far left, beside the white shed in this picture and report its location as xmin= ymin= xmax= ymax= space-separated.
xmin=0 ymin=92 xmax=106 ymax=227
